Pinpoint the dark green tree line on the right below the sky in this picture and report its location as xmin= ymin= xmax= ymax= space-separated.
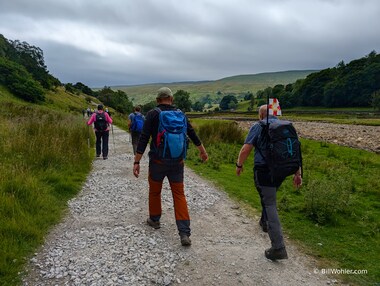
xmin=256 ymin=51 xmax=380 ymax=108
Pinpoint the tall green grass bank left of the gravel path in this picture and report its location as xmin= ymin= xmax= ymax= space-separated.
xmin=0 ymin=99 xmax=94 ymax=285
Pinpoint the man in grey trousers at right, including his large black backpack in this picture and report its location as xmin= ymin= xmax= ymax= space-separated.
xmin=236 ymin=104 xmax=302 ymax=260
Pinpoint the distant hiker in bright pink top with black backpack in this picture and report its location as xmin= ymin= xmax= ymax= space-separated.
xmin=87 ymin=104 xmax=112 ymax=160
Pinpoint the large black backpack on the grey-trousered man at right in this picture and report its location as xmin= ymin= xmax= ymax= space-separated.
xmin=258 ymin=120 xmax=302 ymax=182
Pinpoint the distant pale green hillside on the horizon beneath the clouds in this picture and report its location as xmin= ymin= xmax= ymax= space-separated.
xmin=112 ymin=70 xmax=314 ymax=104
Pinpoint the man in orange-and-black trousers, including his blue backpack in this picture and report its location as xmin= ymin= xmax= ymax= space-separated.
xmin=133 ymin=87 xmax=208 ymax=246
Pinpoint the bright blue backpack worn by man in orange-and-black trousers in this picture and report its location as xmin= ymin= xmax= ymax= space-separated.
xmin=155 ymin=107 xmax=187 ymax=159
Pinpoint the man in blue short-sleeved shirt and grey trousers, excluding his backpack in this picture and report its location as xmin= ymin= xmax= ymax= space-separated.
xmin=236 ymin=105 xmax=302 ymax=260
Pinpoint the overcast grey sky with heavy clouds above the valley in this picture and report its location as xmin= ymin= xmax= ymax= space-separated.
xmin=0 ymin=0 xmax=380 ymax=87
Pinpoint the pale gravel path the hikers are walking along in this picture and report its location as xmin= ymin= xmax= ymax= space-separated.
xmin=23 ymin=127 xmax=339 ymax=286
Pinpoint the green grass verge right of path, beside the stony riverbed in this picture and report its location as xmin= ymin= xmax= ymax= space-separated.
xmin=187 ymin=120 xmax=380 ymax=285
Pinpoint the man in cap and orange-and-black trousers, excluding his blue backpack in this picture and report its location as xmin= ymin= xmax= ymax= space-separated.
xmin=133 ymin=87 xmax=208 ymax=246
